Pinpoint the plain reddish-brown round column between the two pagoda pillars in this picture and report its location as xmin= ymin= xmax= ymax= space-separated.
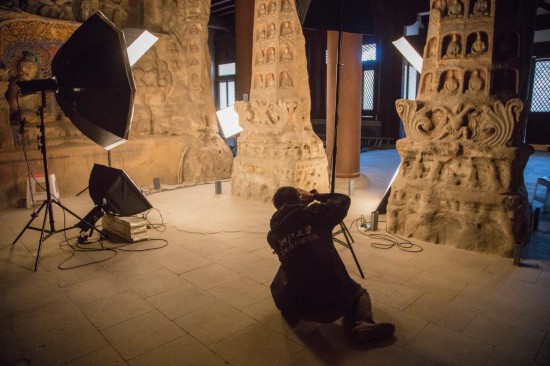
xmin=327 ymin=31 xmax=363 ymax=178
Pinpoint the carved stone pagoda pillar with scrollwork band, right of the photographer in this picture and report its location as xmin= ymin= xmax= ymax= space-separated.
xmin=387 ymin=0 xmax=533 ymax=256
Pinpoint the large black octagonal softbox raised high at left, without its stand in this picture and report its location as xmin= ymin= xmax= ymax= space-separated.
xmin=52 ymin=12 xmax=135 ymax=149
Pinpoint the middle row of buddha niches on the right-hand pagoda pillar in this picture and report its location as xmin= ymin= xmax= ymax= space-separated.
xmin=425 ymin=31 xmax=519 ymax=59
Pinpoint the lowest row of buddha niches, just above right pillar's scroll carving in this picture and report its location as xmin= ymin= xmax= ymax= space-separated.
xmin=420 ymin=69 xmax=517 ymax=95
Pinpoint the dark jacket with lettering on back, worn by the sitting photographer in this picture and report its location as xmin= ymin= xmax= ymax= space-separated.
xmin=267 ymin=193 xmax=360 ymax=322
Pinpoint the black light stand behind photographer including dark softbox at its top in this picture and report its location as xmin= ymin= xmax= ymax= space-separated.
xmin=296 ymin=0 xmax=378 ymax=278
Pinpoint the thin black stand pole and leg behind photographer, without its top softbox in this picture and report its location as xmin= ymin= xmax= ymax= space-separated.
xmin=330 ymin=1 xmax=365 ymax=279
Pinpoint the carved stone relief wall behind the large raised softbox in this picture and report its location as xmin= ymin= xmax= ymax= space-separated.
xmin=0 ymin=0 xmax=233 ymax=199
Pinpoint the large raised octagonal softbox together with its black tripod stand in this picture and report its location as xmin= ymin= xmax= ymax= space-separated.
xmin=13 ymin=12 xmax=153 ymax=271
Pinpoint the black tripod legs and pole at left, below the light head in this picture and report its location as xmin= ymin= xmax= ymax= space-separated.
xmin=13 ymin=89 xmax=94 ymax=272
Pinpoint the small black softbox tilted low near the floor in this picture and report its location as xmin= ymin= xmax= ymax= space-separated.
xmin=89 ymin=164 xmax=153 ymax=216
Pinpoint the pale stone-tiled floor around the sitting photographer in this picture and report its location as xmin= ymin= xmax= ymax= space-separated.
xmin=0 ymin=150 xmax=550 ymax=365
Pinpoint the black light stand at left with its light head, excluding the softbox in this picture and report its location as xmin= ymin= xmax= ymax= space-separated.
xmin=12 ymin=85 xmax=99 ymax=272
